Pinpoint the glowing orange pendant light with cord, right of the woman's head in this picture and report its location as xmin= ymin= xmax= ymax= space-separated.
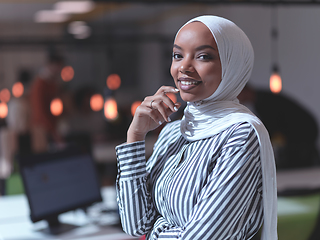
xmin=269 ymin=6 xmax=282 ymax=94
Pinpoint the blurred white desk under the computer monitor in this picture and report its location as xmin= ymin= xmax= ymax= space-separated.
xmin=0 ymin=187 xmax=137 ymax=240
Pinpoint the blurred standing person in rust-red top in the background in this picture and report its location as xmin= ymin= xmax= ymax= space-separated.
xmin=30 ymin=54 xmax=64 ymax=152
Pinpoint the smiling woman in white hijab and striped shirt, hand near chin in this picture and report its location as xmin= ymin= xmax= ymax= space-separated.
xmin=116 ymin=16 xmax=277 ymax=240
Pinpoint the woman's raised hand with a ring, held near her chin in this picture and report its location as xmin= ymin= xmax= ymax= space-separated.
xmin=127 ymin=86 xmax=181 ymax=143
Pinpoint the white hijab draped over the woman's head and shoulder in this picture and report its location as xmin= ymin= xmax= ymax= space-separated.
xmin=178 ymin=15 xmax=278 ymax=240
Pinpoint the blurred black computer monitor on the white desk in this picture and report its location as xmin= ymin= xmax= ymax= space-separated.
xmin=18 ymin=150 xmax=102 ymax=234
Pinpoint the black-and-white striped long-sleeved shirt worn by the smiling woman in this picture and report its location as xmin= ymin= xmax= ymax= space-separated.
xmin=116 ymin=121 xmax=263 ymax=240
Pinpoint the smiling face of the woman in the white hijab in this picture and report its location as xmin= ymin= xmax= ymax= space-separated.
xmin=170 ymin=22 xmax=222 ymax=102
